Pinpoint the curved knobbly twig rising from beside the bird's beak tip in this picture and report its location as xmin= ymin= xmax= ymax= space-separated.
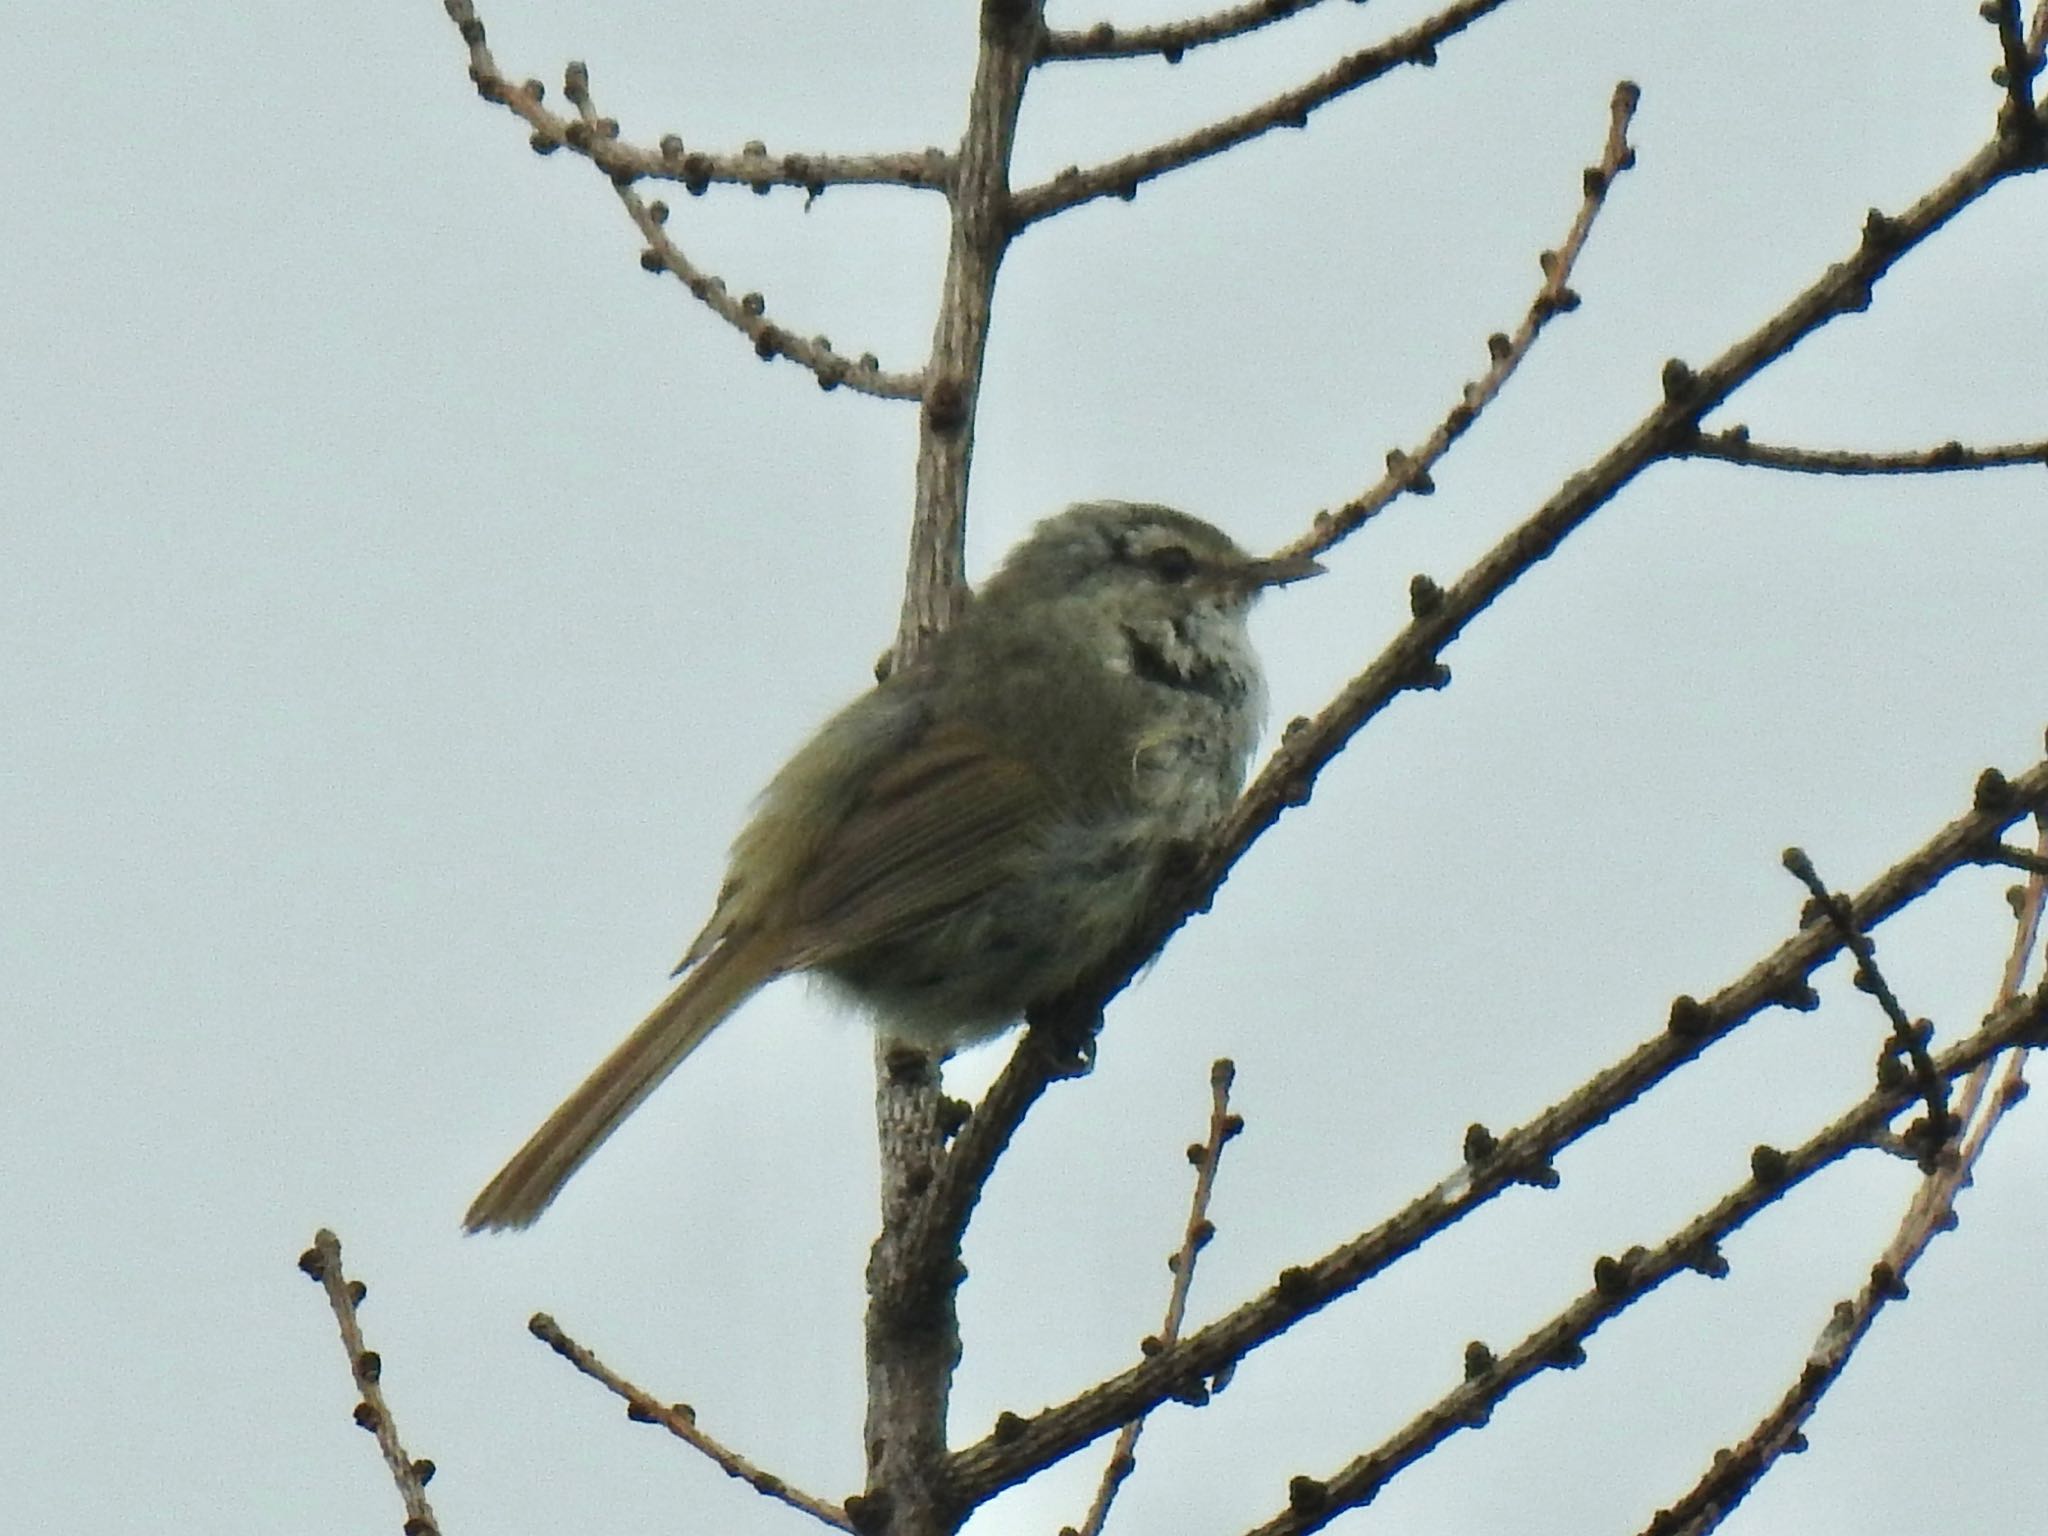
xmin=1286 ymin=80 xmax=1642 ymax=555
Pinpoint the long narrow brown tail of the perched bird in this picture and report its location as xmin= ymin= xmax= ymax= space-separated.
xmin=463 ymin=938 xmax=778 ymax=1233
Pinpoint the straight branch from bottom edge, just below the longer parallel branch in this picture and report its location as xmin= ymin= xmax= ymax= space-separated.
xmin=1249 ymin=987 xmax=2048 ymax=1536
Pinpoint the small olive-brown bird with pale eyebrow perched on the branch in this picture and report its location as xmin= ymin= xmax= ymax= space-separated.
xmin=463 ymin=502 xmax=1323 ymax=1233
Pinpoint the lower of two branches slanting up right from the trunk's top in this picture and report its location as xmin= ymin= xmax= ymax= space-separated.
xmin=1012 ymin=0 xmax=1507 ymax=229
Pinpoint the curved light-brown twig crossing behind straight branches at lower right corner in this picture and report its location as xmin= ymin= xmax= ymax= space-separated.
xmin=1642 ymin=825 xmax=2048 ymax=1536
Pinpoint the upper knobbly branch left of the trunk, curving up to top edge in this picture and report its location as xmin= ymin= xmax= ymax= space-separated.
xmin=444 ymin=0 xmax=952 ymax=197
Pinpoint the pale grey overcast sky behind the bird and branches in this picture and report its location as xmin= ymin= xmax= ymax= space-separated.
xmin=0 ymin=0 xmax=2048 ymax=1536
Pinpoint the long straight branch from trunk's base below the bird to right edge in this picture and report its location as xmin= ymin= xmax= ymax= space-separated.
xmin=948 ymin=760 xmax=2048 ymax=1505
